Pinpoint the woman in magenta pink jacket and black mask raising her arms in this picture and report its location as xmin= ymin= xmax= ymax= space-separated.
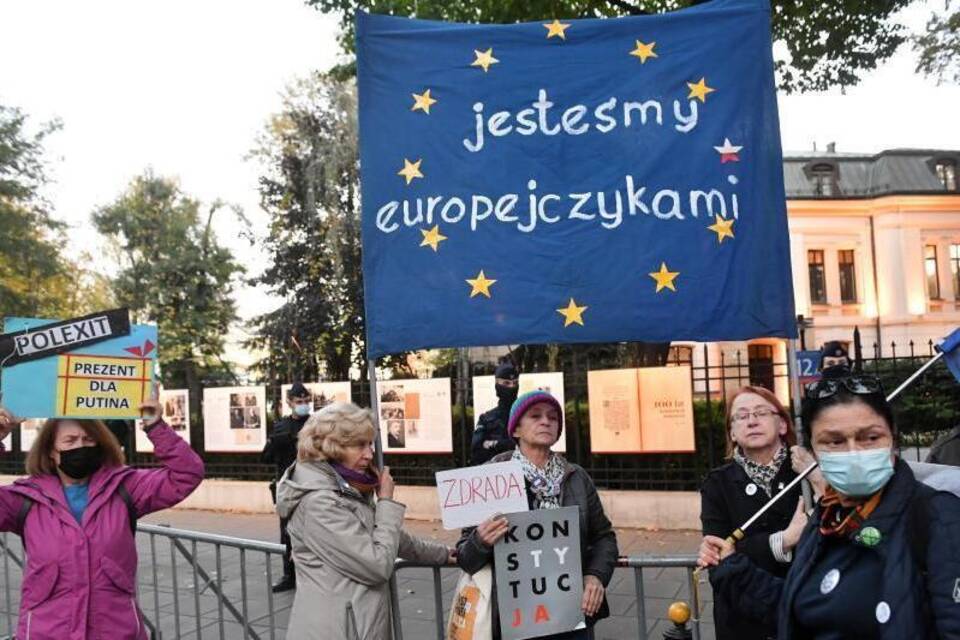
xmin=0 ymin=399 xmax=203 ymax=640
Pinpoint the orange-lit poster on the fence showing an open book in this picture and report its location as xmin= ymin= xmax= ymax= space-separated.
xmin=587 ymin=367 xmax=695 ymax=453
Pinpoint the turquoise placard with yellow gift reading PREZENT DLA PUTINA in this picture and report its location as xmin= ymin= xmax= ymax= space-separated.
xmin=0 ymin=310 xmax=157 ymax=419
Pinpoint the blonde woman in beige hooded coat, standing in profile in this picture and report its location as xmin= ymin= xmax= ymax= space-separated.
xmin=277 ymin=404 xmax=452 ymax=640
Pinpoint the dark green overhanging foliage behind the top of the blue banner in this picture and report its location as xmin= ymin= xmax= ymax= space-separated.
xmin=305 ymin=0 xmax=915 ymax=93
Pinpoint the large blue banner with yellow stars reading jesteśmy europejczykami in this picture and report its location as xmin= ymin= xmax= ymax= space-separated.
xmin=357 ymin=0 xmax=796 ymax=357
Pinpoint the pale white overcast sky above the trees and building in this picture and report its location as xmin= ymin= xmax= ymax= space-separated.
xmin=0 ymin=0 xmax=960 ymax=368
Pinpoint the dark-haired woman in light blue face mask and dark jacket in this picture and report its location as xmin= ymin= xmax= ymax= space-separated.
xmin=711 ymin=376 xmax=960 ymax=640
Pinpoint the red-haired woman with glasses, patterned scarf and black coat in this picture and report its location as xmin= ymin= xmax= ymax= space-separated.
xmin=700 ymin=387 xmax=806 ymax=640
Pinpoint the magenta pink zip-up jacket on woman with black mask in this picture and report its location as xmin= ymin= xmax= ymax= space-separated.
xmin=0 ymin=421 xmax=203 ymax=640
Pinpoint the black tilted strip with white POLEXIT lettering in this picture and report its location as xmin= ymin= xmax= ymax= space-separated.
xmin=0 ymin=309 xmax=130 ymax=367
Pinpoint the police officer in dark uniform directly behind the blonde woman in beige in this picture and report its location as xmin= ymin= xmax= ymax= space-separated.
xmin=260 ymin=382 xmax=313 ymax=593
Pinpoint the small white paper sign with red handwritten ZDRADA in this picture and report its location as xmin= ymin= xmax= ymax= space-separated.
xmin=436 ymin=460 xmax=529 ymax=530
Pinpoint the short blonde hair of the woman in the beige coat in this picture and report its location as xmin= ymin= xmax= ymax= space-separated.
xmin=297 ymin=402 xmax=375 ymax=462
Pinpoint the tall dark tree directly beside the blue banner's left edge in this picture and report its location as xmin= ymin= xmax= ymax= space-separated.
xmin=247 ymin=75 xmax=405 ymax=385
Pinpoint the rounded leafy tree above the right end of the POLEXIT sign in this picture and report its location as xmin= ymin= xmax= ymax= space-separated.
xmin=92 ymin=171 xmax=246 ymax=444
